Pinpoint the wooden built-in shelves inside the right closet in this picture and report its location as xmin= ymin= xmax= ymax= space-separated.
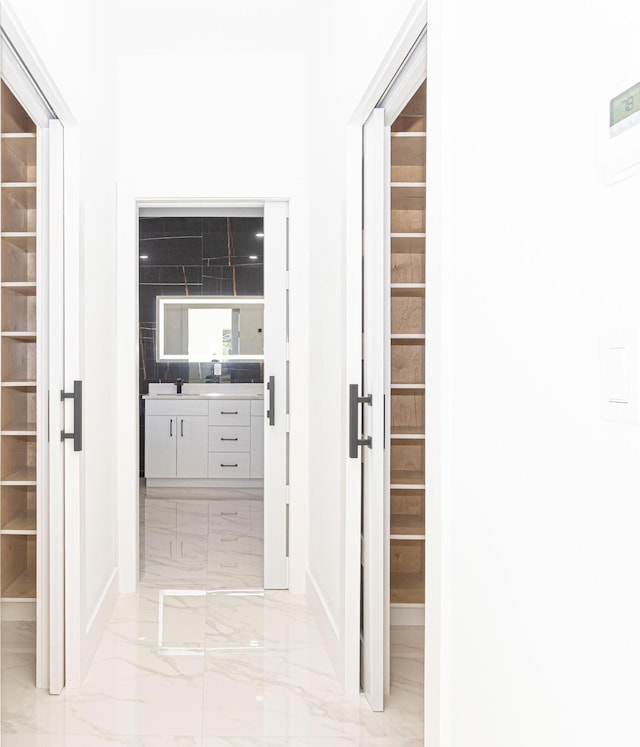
xmin=388 ymin=83 xmax=427 ymax=624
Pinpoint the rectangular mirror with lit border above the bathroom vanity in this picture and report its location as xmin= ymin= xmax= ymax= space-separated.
xmin=156 ymin=296 xmax=264 ymax=363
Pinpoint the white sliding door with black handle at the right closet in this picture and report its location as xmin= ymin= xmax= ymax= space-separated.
xmin=358 ymin=109 xmax=388 ymax=711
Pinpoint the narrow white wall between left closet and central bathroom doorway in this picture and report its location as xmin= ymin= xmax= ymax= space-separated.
xmin=6 ymin=0 xmax=116 ymax=684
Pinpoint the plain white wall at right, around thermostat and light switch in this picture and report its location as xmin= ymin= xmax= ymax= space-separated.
xmin=427 ymin=0 xmax=640 ymax=747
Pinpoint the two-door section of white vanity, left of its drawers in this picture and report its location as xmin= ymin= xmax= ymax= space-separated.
xmin=145 ymin=400 xmax=209 ymax=478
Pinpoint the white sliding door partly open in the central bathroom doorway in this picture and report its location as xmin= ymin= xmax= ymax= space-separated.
xmin=264 ymin=202 xmax=289 ymax=589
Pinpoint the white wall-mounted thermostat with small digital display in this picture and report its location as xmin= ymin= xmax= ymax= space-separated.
xmin=597 ymin=75 xmax=640 ymax=184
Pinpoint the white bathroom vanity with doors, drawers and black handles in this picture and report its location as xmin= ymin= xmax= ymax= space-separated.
xmin=143 ymin=384 xmax=264 ymax=487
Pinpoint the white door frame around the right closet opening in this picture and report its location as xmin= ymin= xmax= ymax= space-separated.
xmin=343 ymin=0 xmax=452 ymax=747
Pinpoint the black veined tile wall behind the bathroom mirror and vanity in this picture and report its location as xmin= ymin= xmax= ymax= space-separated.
xmin=139 ymin=218 xmax=264 ymax=474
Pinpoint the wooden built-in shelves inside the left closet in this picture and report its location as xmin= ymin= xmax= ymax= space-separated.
xmin=0 ymin=83 xmax=38 ymax=617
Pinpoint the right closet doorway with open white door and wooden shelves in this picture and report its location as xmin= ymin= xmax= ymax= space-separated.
xmin=350 ymin=34 xmax=427 ymax=711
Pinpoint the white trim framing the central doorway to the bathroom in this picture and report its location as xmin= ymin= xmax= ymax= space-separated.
xmin=116 ymin=180 xmax=309 ymax=593
